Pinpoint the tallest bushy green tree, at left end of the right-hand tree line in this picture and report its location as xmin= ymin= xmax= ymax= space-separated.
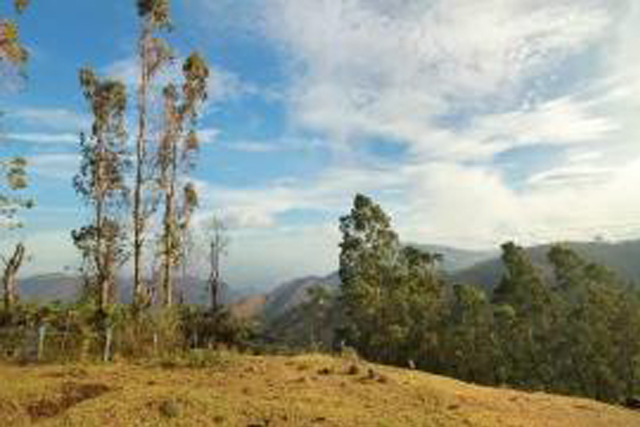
xmin=339 ymin=195 xmax=444 ymax=363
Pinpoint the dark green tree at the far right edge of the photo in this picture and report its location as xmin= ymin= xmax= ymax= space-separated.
xmin=548 ymin=245 xmax=640 ymax=402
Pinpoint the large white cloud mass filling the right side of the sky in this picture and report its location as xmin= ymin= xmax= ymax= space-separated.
xmin=244 ymin=0 xmax=640 ymax=251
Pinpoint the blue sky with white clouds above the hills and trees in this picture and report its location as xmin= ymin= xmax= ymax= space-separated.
xmin=0 ymin=0 xmax=640 ymax=287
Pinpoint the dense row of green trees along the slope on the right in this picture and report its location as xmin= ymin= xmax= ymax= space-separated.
xmin=334 ymin=195 xmax=640 ymax=402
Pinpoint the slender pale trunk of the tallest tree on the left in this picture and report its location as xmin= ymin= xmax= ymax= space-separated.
xmin=133 ymin=23 xmax=151 ymax=304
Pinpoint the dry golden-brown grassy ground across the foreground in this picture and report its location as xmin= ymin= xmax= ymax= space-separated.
xmin=0 ymin=355 xmax=640 ymax=427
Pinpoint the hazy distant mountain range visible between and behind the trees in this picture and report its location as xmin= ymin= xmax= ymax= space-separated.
xmin=15 ymin=240 xmax=640 ymax=319
